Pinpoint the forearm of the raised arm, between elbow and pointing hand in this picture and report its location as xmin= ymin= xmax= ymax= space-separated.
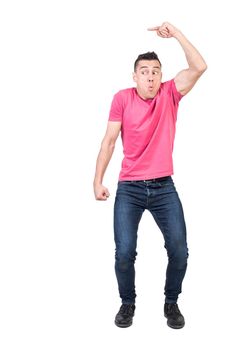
xmin=173 ymin=30 xmax=207 ymax=72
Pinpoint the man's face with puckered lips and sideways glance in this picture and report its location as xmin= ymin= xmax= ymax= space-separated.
xmin=133 ymin=60 xmax=162 ymax=99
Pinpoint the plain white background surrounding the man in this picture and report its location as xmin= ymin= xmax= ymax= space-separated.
xmin=0 ymin=0 xmax=234 ymax=350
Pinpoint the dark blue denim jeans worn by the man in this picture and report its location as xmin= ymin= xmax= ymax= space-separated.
xmin=114 ymin=176 xmax=188 ymax=304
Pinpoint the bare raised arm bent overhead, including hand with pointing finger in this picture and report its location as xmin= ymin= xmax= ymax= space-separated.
xmin=148 ymin=22 xmax=207 ymax=95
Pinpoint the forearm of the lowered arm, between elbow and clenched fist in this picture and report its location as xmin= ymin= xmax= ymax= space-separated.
xmin=93 ymin=144 xmax=115 ymax=185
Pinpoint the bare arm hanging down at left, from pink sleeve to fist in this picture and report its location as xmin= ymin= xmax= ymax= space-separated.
xmin=93 ymin=121 xmax=121 ymax=200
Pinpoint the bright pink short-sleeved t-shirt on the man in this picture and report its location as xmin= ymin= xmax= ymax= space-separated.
xmin=109 ymin=80 xmax=183 ymax=181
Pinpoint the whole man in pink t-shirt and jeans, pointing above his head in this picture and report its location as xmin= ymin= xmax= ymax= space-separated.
xmin=94 ymin=22 xmax=207 ymax=329
